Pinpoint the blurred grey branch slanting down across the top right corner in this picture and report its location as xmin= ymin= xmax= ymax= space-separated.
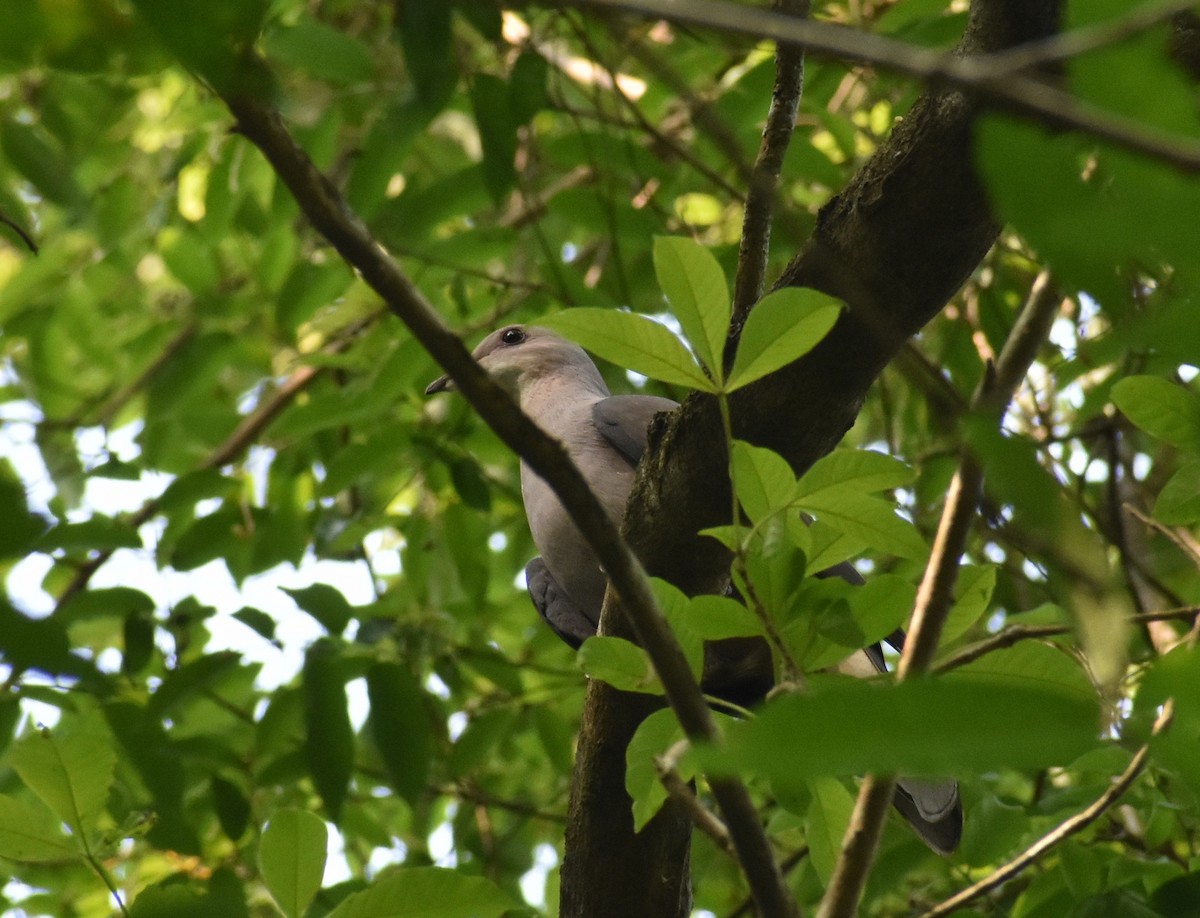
xmin=569 ymin=0 xmax=1200 ymax=172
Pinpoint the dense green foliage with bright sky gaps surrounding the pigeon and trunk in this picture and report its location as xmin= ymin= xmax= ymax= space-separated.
xmin=0 ymin=0 xmax=1200 ymax=918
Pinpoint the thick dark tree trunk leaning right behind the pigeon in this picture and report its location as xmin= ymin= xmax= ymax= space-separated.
xmin=562 ymin=0 xmax=1058 ymax=917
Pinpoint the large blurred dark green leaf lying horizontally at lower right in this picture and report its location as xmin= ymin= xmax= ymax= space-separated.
xmin=704 ymin=673 xmax=1100 ymax=784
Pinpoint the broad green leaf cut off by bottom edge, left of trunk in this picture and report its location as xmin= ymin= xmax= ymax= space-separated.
xmin=329 ymin=868 xmax=517 ymax=918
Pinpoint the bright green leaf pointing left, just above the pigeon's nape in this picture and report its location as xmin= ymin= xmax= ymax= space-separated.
xmin=539 ymin=307 xmax=716 ymax=392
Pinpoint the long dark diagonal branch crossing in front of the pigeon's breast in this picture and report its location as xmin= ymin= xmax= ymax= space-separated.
xmin=223 ymin=95 xmax=797 ymax=916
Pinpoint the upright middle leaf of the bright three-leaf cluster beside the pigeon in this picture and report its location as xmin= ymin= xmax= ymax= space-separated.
xmin=654 ymin=236 xmax=731 ymax=378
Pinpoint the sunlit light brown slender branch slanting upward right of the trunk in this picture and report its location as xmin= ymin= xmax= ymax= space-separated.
xmin=818 ymin=271 xmax=1061 ymax=918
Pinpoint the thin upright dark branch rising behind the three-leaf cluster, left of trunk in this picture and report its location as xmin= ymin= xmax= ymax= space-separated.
xmin=732 ymin=0 xmax=810 ymax=329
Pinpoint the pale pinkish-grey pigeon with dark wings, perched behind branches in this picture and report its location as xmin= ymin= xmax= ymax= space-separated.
xmin=426 ymin=325 xmax=962 ymax=854
